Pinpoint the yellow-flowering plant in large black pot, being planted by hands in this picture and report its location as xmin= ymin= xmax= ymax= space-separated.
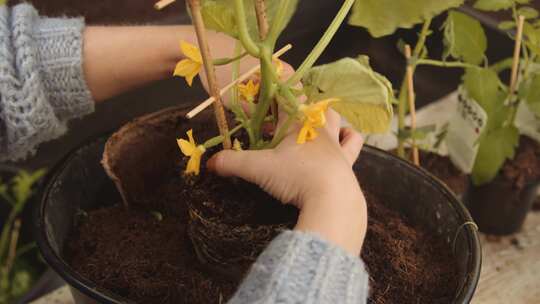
xmin=33 ymin=0 xmax=480 ymax=303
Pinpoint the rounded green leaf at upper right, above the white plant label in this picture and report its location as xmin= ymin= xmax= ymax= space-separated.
xmin=444 ymin=11 xmax=487 ymax=64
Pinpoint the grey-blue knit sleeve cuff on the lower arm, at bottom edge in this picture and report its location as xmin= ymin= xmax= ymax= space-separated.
xmin=229 ymin=231 xmax=369 ymax=304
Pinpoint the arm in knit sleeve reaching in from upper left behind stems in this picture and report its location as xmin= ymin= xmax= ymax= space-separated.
xmin=0 ymin=4 xmax=249 ymax=160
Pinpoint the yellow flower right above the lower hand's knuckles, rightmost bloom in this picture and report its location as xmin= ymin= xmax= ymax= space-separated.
xmin=296 ymin=98 xmax=339 ymax=144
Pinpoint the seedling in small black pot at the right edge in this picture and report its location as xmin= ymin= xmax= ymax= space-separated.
xmin=454 ymin=1 xmax=540 ymax=234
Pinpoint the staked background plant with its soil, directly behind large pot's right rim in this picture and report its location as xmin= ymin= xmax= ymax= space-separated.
xmin=349 ymin=0 xmax=487 ymax=197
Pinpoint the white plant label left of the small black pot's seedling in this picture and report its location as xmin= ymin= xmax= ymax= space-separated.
xmin=446 ymin=87 xmax=488 ymax=174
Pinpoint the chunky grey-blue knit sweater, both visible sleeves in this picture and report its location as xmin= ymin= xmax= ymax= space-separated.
xmin=0 ymin=4 xmax=368 ymax=304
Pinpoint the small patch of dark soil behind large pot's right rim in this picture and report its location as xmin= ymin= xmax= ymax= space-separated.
xmin=420 ymin=151 xmax=469 ymax=195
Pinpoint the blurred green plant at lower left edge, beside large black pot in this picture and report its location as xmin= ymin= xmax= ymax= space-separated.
xmin=0 ymin=167 xmax=44 ymax=304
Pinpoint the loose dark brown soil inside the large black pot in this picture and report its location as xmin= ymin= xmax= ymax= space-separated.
xmin=67 ymin=184 xmax=456 ymax=304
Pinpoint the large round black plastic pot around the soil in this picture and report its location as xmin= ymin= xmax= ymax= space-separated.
xmin=34 ymin=132 xmax=481 ymax=304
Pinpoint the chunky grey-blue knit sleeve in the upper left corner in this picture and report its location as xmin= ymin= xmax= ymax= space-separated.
xmin=0 ymin=4 xmax=94 ymax=161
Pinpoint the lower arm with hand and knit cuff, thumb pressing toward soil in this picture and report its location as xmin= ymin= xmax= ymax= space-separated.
xmin=208 ymin=111 xmax=368 ymax=304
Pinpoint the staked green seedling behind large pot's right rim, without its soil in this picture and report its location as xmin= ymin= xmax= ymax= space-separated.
xmin=349 ymin=0 xmax=487 ymax=163
